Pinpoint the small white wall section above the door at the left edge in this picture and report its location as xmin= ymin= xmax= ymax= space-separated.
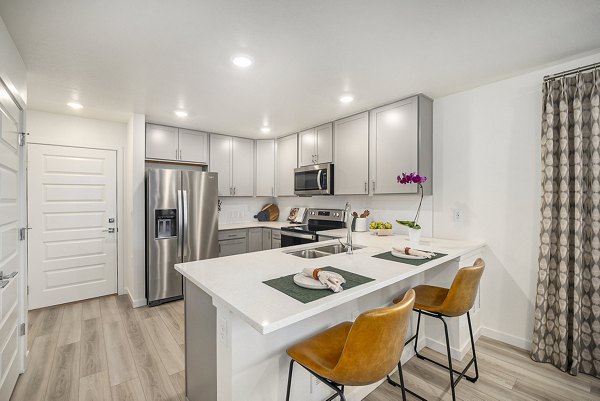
xmin=0 ymin=18 xmax=27 ymax=105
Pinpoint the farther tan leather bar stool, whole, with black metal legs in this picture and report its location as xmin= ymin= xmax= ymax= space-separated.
xmin=388 ymin=258 xmax=485 ymax=400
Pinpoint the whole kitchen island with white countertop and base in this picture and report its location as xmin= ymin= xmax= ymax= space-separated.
xmin=176 ymin=231 xmax=484 ymax=401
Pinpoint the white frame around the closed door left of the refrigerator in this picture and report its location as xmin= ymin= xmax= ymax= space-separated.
xmin=27 ymin=142 xmax=125 ymax=295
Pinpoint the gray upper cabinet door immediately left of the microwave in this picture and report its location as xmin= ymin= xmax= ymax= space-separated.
xmin=275 ymin=134 xmax=298 ymax=196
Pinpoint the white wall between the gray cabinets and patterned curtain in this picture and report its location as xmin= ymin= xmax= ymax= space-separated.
xmin=433 ymin=50 xmax=600 ymax=348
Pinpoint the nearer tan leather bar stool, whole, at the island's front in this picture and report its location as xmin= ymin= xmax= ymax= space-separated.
xmin=286 ymin=290 xmax=415 ymax=401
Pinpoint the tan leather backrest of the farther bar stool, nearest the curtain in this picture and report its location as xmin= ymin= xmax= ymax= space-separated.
xmin=440 ymin=258 xmax=485 ymax=317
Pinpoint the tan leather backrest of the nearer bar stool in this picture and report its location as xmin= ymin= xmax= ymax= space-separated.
xmin=331 ymin=289 xmax=415 ymax=386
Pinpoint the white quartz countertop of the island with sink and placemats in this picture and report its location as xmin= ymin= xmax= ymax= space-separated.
xmin=175 ymin=231 xmax=485 ymax=334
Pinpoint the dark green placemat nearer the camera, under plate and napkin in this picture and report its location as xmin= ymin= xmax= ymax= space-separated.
xmin=263 ymin=266 xmax=375 ymax=304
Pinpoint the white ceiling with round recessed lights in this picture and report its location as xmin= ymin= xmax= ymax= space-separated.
xmin=0 ymin=0 xmax=600 ymax=138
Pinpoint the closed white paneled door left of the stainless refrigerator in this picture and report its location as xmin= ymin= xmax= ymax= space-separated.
xmin=28 ymin=144 xmax=117 ymax=309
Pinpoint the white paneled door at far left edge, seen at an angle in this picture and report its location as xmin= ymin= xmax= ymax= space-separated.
xmin=0 ymin=81 xmax=27 ymax=400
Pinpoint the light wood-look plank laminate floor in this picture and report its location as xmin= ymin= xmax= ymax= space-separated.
xmin=11 ymin=296 xmax=600 ymax=401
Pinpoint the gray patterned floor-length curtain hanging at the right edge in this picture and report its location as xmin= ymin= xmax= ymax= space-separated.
xmin=531 ymin=70 xmax=600 ymax=377
